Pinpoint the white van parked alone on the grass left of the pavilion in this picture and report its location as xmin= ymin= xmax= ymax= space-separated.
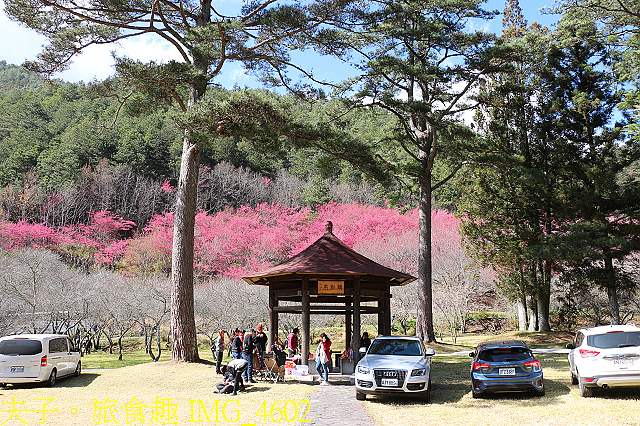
xmin=0 ymin=334 xmax=82 ymax=386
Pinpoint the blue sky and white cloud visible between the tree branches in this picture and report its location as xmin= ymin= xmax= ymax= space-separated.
xmin=0 ymin=0 xmax=557 ymax=88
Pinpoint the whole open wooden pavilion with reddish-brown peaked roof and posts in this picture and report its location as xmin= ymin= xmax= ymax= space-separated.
xmin=243 ymin=222 xmax=416 ymax=365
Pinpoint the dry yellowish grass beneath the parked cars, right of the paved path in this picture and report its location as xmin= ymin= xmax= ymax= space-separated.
xmin=364 ymin=352 xmax=640 ymax=425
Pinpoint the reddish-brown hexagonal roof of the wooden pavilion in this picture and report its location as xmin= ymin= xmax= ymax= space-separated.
xmin=242 ymin=222 xmax=416 ymax=285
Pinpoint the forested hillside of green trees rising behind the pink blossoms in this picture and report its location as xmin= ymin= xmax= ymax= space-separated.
xmin=0 ymin=65 xmax=408 ymax=226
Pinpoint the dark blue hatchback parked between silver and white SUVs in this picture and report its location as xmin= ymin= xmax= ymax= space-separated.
xmin=469 ymin=340 xmax=545 ymax=398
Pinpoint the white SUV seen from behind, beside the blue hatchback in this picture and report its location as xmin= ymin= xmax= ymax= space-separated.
xmin=567 ymin=325 xmax=640 ymax=397
